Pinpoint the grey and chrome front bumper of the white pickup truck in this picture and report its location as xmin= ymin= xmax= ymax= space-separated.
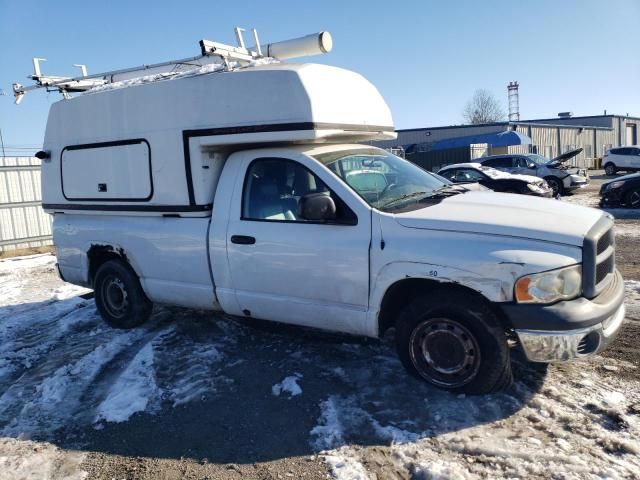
xmin=502 ymin=271 xmax=625 ymax=362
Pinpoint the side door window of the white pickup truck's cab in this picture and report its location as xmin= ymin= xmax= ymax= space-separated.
xmin=242 ymin=158 xmax=357 ymax=224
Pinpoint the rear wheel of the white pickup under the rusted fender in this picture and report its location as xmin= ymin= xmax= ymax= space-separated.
xmin=93 ymin=260 xmax=153 ymax=329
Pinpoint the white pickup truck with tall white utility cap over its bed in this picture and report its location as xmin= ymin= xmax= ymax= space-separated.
xmin=30 ymin=32 xmax=625 ymax=393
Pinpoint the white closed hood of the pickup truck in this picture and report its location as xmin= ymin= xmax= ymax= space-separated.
xmin=395 ymin=192 xmax=604 ymax=247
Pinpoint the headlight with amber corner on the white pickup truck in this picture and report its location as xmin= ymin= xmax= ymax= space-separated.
xmin=515 ymin=265 xmax=582 ymax=303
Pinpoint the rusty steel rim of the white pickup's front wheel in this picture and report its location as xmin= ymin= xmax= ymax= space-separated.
xmin=409 ymin=318 xmax=480 ymax=388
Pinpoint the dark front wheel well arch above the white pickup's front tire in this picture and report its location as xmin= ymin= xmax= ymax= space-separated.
xmin=378 ymin=278 xmax=513 ymax=337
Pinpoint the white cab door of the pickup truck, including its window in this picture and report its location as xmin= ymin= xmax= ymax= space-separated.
xmin=224 ymin=155 xmax=371 ymax=333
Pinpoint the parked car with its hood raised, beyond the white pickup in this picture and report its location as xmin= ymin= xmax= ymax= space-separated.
xmin=476 ymin=148 xmax=589 ymax=196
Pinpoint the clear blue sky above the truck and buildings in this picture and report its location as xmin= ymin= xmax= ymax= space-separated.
xmin=0 ymin=0 xmax=640 ymax=155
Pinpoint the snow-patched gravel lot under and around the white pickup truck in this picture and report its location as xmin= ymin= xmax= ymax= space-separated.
xmin=0 ymin=172 xmax=640 ymax=480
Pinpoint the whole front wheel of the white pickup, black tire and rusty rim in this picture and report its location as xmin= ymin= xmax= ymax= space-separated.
xmin=396 ymin=289 xmax=513 ymax=395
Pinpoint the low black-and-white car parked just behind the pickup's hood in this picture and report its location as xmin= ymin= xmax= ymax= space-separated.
xmin=438 ymin=163 xmax=553 ymax=198
